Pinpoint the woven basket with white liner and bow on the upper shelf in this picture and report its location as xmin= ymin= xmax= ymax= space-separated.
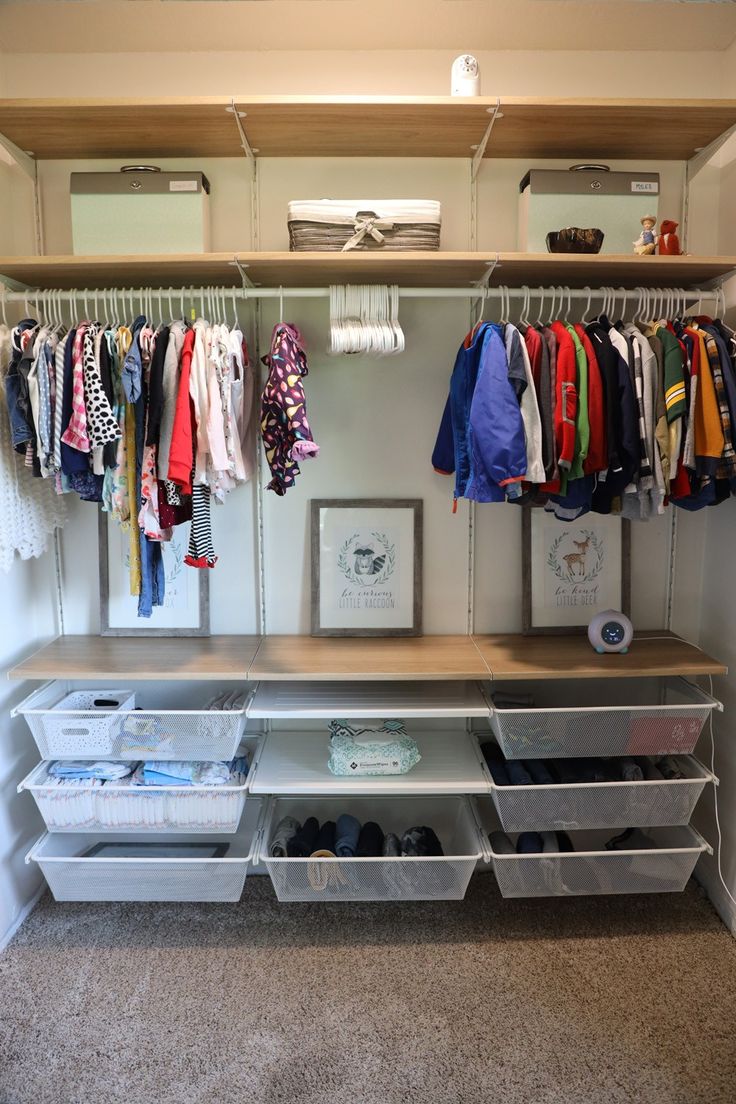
xmin=288 ymin=200 xmax=441 ymax=252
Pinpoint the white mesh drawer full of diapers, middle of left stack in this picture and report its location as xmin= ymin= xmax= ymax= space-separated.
xmin=18 ymin=737 xmax=260 ymax=832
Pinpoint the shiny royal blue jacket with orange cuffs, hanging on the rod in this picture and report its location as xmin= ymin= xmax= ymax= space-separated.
xmin=433 ymin=322 xmax=526 ymax=502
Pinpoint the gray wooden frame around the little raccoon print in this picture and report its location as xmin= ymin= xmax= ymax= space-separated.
xmin=310 ymin=498 xmax=424 ymax=637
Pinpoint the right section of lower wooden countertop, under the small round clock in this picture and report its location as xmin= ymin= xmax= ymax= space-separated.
xmin=473 ymin=631 xmax=728 ymax=681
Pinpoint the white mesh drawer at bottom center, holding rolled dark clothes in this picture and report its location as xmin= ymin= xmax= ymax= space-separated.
xmin=257 ymin=797 xmax=484 ymax=901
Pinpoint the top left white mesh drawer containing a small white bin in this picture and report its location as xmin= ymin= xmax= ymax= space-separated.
xmin=13 ymin=682 xmax=250 ymax=761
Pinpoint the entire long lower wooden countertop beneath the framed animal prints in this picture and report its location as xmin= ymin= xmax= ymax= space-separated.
xmin=9 ymin=631 xmax=727 ymax=686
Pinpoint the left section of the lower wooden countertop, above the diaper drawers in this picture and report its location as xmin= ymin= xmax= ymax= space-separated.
xmin=8 ymin=636 xmax=260 ymax=686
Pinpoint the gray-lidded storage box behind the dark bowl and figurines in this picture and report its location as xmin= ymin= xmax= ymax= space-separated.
xmin=519 ymin=166 xmax=660 ymax=254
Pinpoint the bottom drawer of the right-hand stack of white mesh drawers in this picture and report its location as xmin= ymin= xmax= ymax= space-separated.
xmin=489 ymin=826 xmax=712 ymax=898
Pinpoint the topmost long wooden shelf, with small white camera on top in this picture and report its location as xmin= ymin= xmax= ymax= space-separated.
xmin=0 ymin=96 xmax=736 ymax=160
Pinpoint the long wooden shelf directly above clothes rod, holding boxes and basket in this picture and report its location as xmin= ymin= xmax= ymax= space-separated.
xmin=0 ymin=251 xmax=736 ymax=288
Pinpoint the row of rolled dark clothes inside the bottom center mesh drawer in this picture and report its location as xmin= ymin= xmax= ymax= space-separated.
xmin=269 ymin=813 xmax=444 ymax=859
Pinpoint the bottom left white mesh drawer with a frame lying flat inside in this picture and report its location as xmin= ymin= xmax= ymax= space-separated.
xmin=25 ymin=802 xmax=259 ymax=901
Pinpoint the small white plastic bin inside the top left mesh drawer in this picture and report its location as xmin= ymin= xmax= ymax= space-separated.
xmin=18 ymin=689 xmax=136 ymax=758
